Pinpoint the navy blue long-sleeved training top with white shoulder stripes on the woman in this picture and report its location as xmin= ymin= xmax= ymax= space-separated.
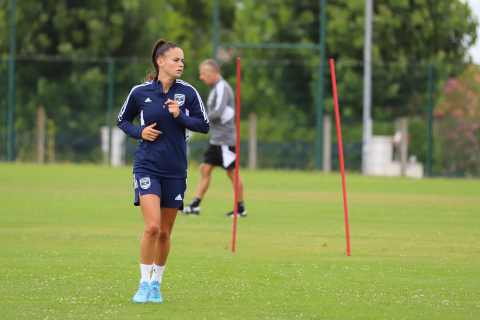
xmin=117 ymin=79 xmax=210 ymax=179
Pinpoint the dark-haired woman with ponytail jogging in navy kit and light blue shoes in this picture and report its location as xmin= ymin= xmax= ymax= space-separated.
xmin=117 ymin=40 xmax=210 ymax=303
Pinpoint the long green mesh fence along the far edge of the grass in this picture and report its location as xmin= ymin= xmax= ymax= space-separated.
xmin=0 ymin=57 xmax=480 ymax=176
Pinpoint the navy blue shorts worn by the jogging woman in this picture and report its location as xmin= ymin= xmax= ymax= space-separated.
xmin=133 ymin=173 xmax=187 ymax=210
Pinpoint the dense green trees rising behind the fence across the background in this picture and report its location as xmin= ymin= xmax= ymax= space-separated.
xmin=0 ymin=0 xmax=478 ymax=170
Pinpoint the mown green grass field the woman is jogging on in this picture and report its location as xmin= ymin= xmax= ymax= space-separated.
xmin=0 ymin=164 xmax=480 ymax=319
